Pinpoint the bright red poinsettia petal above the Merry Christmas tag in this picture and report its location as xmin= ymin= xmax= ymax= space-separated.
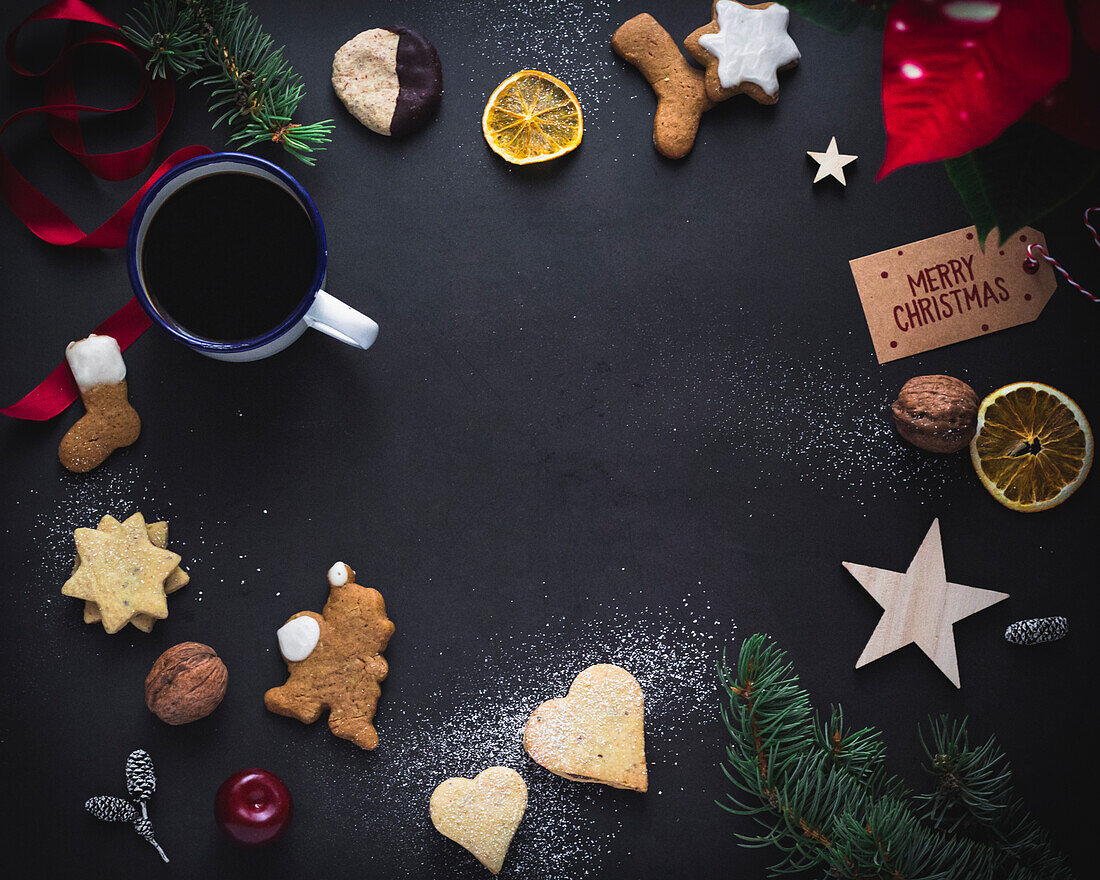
xmin=879 ymin=0 xmax=1070 ymax=179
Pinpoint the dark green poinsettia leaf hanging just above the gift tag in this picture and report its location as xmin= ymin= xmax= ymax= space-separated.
xmin=944 ymin=122 xmax=1100 ymax=242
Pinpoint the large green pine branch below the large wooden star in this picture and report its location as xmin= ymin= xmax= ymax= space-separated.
xmin=718 ymin=635 xmax=1070 ymax=880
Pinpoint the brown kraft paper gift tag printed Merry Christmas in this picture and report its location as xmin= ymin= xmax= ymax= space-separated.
xmin=849 ymin=227 xmax=1057 ymax=364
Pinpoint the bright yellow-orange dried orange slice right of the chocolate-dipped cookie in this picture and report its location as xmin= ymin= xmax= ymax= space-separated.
xmin=482 ymin=70 xmax=584 ymax=165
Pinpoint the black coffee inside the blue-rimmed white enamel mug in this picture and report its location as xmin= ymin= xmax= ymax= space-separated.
xmin=141 ymin=172 xmax=317 ymax=342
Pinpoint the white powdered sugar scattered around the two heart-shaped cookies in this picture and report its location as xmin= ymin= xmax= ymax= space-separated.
xmin=294 ymin=586 xmax=735 ymax=878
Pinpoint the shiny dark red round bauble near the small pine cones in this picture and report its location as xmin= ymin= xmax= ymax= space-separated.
xmin=213 ymin=768 xmax=294 ymax=846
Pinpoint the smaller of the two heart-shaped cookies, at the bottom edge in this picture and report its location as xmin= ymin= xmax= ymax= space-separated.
xmin=429 ymin=767 xmax=527 ymax=873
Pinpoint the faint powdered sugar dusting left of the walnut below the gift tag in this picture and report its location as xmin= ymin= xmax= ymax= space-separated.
xmin=653 ymin=328 xmax=970 ymax=498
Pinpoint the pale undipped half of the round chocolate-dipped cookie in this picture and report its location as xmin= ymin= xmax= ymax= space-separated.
xmin=332 ymin=28 xmax=400 ymax=135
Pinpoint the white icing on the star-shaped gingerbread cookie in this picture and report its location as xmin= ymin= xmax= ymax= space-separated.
xmin=699 ymin=0 xmax=802 ymax=97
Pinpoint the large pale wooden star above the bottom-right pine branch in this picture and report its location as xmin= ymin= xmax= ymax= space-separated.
xmin=844 ymin=519 xmax=1009 ymax=688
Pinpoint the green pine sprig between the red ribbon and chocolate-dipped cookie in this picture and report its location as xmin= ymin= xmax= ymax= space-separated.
xmin=123 ymin=0 xmax=332 ymax=165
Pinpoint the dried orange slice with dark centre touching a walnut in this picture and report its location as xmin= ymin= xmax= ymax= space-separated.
xmin=970 ymin=382 xmax=1092 ymax=514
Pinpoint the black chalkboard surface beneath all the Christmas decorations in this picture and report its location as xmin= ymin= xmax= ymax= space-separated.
xmin=0 ymin=0 xmax=1100 ymax=878
